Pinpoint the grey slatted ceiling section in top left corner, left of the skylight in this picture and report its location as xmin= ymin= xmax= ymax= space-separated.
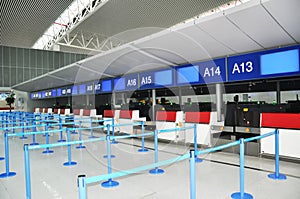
xmin=0 ymin=0 xmax=73 ymax=48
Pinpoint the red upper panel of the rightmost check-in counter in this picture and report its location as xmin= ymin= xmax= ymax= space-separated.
xmin=261 ymin=113 xmax=300 ymax=129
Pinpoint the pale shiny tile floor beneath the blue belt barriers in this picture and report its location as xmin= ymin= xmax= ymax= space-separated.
xmin=0 ymin=128 xmax=300 ymax=199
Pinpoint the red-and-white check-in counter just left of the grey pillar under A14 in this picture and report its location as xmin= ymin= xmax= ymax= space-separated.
xmin=185 ymin=112 xmax=212 ymax=146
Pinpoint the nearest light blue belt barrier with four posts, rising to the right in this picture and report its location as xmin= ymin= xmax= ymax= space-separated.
xmin=77 ymin=128 xmax=286 ymax=199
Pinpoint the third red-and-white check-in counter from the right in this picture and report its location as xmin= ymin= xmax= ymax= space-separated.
xmin=156 ymin=111 xmax=185 ymax=141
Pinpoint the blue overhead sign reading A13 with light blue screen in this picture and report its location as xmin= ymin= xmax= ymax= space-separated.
xmin=228 ymin=46 xmax=300 ymax=81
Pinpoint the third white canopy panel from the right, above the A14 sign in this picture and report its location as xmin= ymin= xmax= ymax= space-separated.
xmin=197 ymin=15 xmax=261 ymax=53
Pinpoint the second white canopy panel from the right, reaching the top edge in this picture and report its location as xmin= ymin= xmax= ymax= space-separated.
xmin=225 ymin=1 xmax=294 ymax=48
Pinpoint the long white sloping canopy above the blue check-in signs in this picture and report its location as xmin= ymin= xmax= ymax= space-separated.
xmin=3 ymin=0 xmax=300 ymax=91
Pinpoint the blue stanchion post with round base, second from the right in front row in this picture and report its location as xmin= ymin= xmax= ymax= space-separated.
xmin=231 ymin=138 xmax=253 ymax=199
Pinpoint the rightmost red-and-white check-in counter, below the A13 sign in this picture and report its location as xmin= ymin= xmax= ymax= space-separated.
xmin=260 ymin=113 xmax=300 ymax=158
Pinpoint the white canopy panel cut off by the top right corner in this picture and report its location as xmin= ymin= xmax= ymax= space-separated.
xmin=263 ymin=0 xmax=300 ymax=43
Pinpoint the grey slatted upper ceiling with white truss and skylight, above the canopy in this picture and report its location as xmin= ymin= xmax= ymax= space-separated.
xmin=0 ymin=0 xmax=233 ymax=54
